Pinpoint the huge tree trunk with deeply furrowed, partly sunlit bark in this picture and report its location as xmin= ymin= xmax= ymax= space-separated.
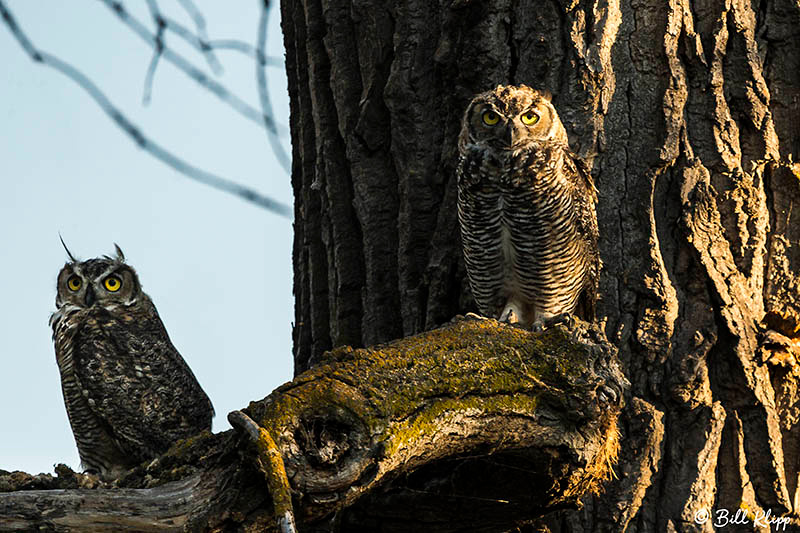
xmin=290 ymin=0 xmax=800 ymax=531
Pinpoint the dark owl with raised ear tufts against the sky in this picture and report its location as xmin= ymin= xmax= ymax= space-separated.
xmin=50 ymin=245 xmax=214 ymax=479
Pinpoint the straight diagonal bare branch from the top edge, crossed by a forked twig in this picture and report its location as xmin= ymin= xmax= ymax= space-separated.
xmin=100 ymin=0 xmax=286 ymax=137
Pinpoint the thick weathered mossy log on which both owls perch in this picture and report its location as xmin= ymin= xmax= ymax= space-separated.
xmin=0 ymin=319 xmax=627 ymax=532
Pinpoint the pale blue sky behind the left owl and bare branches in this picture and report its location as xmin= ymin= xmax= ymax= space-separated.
xmin=0 ymin=0 xmax=293 ymax=472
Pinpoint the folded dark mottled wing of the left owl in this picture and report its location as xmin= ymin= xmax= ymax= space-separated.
xmin=74 ymin=302 xmax=214 ymax=460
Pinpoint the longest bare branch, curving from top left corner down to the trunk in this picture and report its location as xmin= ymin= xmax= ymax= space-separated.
xmin=0 ymin=0 xmax=291 ymax=218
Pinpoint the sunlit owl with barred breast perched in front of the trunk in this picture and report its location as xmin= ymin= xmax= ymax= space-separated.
xmin=457 ymin=85 xmax=600 ymax=327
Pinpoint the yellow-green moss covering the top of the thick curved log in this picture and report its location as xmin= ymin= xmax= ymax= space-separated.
xmin=248 ymin=320 xmax=590 ymax=454
